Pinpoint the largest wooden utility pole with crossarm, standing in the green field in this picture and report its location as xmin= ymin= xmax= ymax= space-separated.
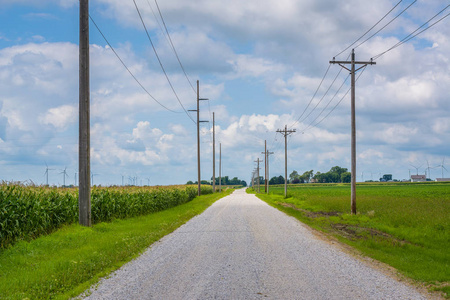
xmin=330 ymin=49 xmax=376 ymax=215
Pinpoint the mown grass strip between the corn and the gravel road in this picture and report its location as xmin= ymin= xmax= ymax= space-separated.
xmin=0 ymin=190 xmax=232 ymax=299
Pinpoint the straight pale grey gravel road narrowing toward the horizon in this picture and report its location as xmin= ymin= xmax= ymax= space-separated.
xmin=82 ymin=190 xmax=426 ymax=299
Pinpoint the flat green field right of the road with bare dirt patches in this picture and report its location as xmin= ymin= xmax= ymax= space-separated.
xmin=258 ymin=183 xmax=450 ymax=297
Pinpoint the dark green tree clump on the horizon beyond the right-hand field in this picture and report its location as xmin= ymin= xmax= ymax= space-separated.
xmin=269 ymin=166 xmax=352 ymax=185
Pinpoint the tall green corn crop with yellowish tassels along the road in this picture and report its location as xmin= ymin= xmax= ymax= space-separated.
xmin=0 ymin=184 xmax=212 ymax=248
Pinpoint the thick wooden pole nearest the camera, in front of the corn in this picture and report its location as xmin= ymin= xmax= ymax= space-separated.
xmin=78 ymin=0 xmax=91 ymax=226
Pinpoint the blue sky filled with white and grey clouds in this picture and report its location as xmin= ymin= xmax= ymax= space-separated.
xmin=0 ymin=0 xmax=450 ymax=185
